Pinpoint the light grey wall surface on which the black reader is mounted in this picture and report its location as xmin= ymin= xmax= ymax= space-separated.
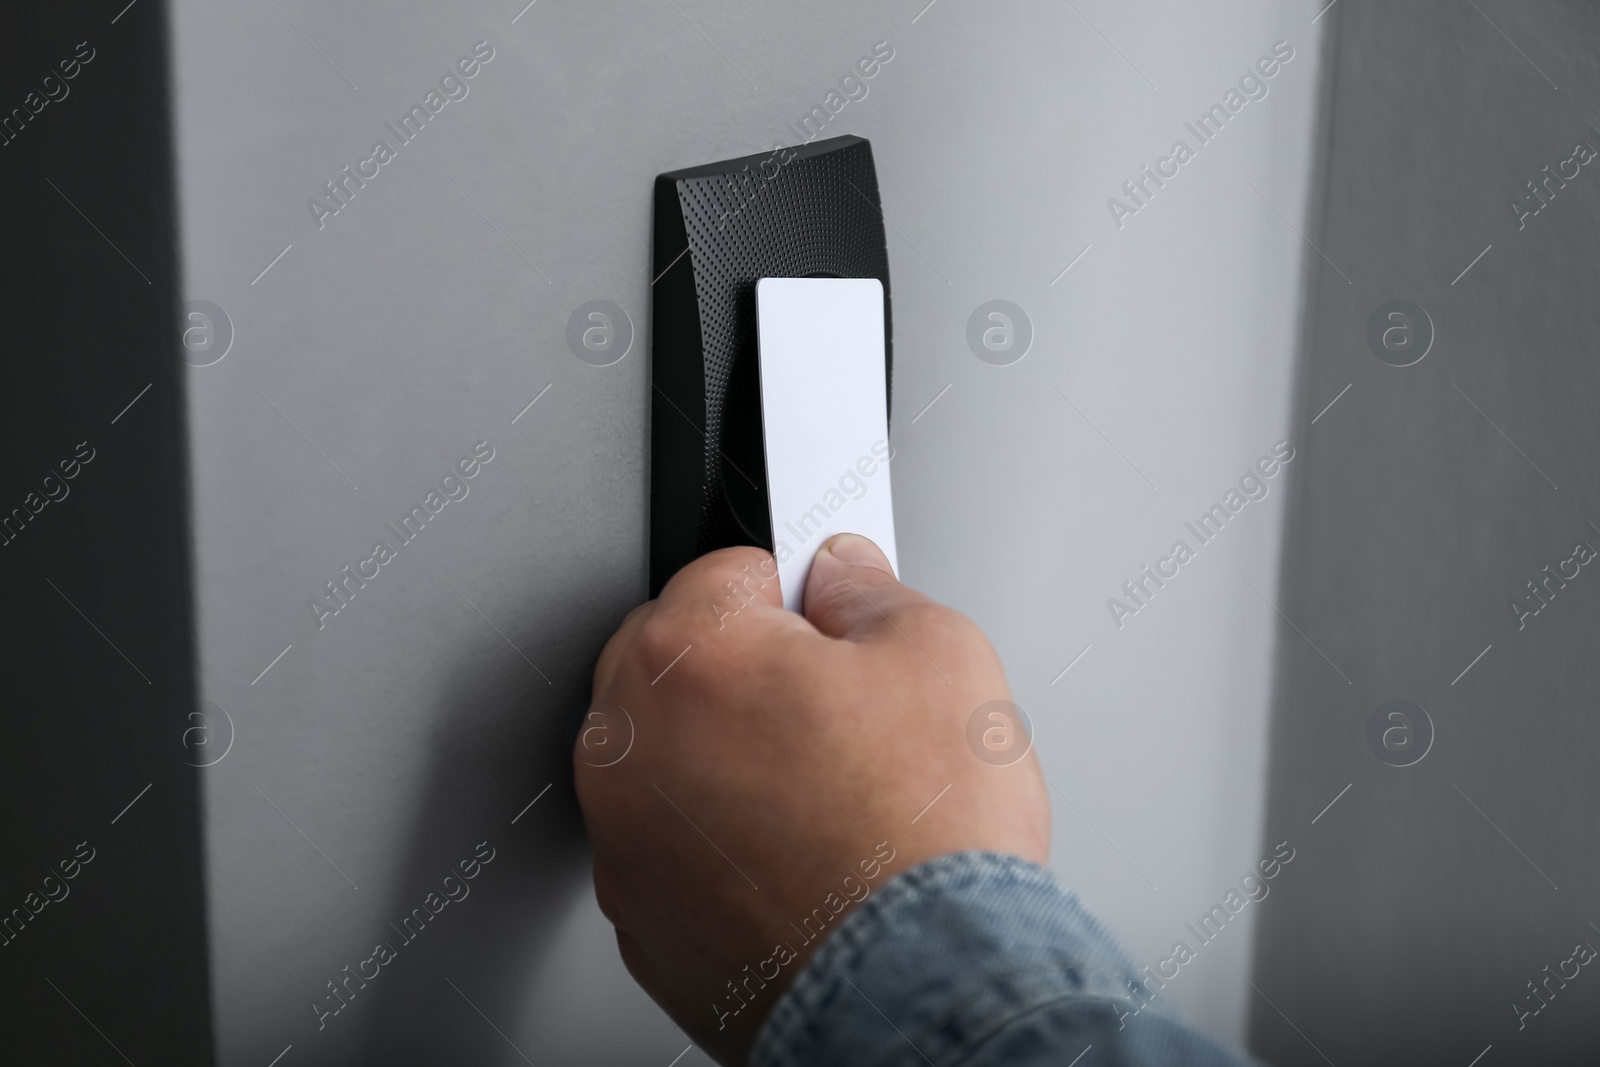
xmin=171 ymin=0 xmax=1323 ymax=1067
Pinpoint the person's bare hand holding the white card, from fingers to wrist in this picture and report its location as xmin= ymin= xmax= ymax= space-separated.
xmin=574 ymin=534 xmax=1050 ymax=1064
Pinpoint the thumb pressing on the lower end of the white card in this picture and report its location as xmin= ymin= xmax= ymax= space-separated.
xmin=803 ymin=534 xmax=928 ymax=641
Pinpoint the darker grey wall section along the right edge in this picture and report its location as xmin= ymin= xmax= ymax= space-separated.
xmin=1251 ymin=0 xmax=1600 ymax=1065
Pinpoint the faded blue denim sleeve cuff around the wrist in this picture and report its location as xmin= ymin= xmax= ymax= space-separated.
xmin=749 ymin=853 xmax=1251 ymax=1067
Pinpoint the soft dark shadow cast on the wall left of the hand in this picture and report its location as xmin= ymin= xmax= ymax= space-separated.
xmin=342 ymin=568 xmax=604 ymax=1062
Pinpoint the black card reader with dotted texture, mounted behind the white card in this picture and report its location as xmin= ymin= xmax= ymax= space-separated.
xmin=650 ymin=138 xmax=893 ymax=595
